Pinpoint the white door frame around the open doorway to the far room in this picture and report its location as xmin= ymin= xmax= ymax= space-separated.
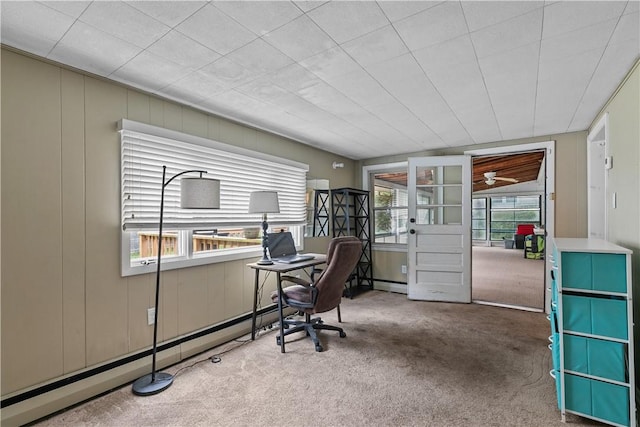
xmin=464 ymin=140 xmax=556 ymax=313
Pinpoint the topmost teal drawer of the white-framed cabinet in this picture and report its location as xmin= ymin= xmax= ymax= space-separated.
xmin=561 ymin=252 xmax=627 ymax=293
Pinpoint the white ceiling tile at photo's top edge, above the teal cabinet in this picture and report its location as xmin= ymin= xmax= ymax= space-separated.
xmin=542 ymin=1 xmax=627 ymax=39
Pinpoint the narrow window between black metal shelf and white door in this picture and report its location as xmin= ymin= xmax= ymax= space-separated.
xmin=373 ymin=171 xmax=409 ymax=244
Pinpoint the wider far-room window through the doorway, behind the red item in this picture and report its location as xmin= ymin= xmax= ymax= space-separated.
xmin=490 ymin=196 xmax=540 ymax=240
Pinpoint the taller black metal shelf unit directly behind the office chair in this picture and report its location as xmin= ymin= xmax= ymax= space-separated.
xmin=330 ymin=188 xmax=373 ymax=297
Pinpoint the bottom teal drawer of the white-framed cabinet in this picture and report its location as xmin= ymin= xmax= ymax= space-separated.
xmin=564 ymin=374 xmax=630 ymax=426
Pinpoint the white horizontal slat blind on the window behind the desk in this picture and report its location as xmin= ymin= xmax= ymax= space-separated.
xmin=119 ymin=119 xmax=309 ymax=230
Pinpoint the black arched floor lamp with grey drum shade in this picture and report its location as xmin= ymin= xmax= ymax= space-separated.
xmin=133 ymin=166 xmax=220 ymax=396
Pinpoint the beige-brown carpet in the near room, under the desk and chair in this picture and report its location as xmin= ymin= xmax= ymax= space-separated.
xmin=37 ymin=291 xmax=600 ymax=427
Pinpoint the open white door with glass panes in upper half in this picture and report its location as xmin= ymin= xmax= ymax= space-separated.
xmin=407 ymin=156 xmax=471 ymax=303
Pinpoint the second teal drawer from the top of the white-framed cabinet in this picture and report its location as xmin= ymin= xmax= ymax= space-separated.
xmin=562 ymin=294 xmax=628 ymax=340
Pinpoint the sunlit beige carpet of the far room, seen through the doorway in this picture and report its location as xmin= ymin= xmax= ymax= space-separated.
xmin=471 ymin=246 xmax=545 ymax=310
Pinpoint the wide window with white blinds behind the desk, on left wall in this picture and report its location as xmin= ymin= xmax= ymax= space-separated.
xmin=120 ymin=120 xmax=308 ymax=275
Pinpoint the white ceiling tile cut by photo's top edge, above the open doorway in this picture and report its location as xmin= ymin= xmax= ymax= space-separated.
xmin=461 ymin=1 xmax=544 ymax=32
